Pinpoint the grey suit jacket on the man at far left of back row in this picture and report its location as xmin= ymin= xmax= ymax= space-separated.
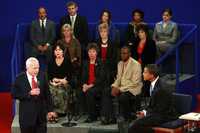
xmin=30 ymin=19 xmax=56 ymax=46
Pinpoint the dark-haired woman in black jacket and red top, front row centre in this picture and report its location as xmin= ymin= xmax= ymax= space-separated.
xmin=79 ymin=43 xmax=105 ymax=123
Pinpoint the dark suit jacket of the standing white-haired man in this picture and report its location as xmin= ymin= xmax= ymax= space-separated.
xmin=11 ymin=72 xmax=53 ymax=126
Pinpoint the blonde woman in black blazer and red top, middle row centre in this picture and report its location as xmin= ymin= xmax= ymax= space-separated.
xmin=97 ymin=23 xmax=119 ymax=86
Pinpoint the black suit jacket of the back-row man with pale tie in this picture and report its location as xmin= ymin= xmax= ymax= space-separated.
xmin=60 ymin=15 xmax=88 ymax=46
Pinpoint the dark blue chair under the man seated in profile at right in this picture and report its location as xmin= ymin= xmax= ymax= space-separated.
xmin=153 ymin=93 xmax=192 ymax=133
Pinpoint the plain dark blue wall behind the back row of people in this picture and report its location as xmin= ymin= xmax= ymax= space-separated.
xmin=0 ymin=0 xmax=200 ymax=91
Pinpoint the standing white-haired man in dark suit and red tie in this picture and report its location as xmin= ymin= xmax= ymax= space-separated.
xmin=11 ymin=57 xmax=55 ymax=133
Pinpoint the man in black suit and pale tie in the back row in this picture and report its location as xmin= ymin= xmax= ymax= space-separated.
xmin=60 ymin=1 xmax=88 ymax=57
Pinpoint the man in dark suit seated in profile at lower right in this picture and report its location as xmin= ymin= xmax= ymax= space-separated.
xmin=128 ymin=64 xmax=177 ymax=133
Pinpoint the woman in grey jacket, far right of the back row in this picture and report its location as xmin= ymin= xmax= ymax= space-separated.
xmin=153 ymin=9 xmax=178 ymax=55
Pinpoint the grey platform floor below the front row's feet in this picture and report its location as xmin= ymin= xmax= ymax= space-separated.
xmin=11 ymin=115 xmax=118 ymax=133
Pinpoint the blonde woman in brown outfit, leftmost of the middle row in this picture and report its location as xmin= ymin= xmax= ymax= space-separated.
xmin=58 ymin=24 xmax=82 ymax=88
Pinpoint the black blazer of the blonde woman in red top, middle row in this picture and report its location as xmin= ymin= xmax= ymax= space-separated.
xmin=97 ymin=40 xmax=118 ymax=86
